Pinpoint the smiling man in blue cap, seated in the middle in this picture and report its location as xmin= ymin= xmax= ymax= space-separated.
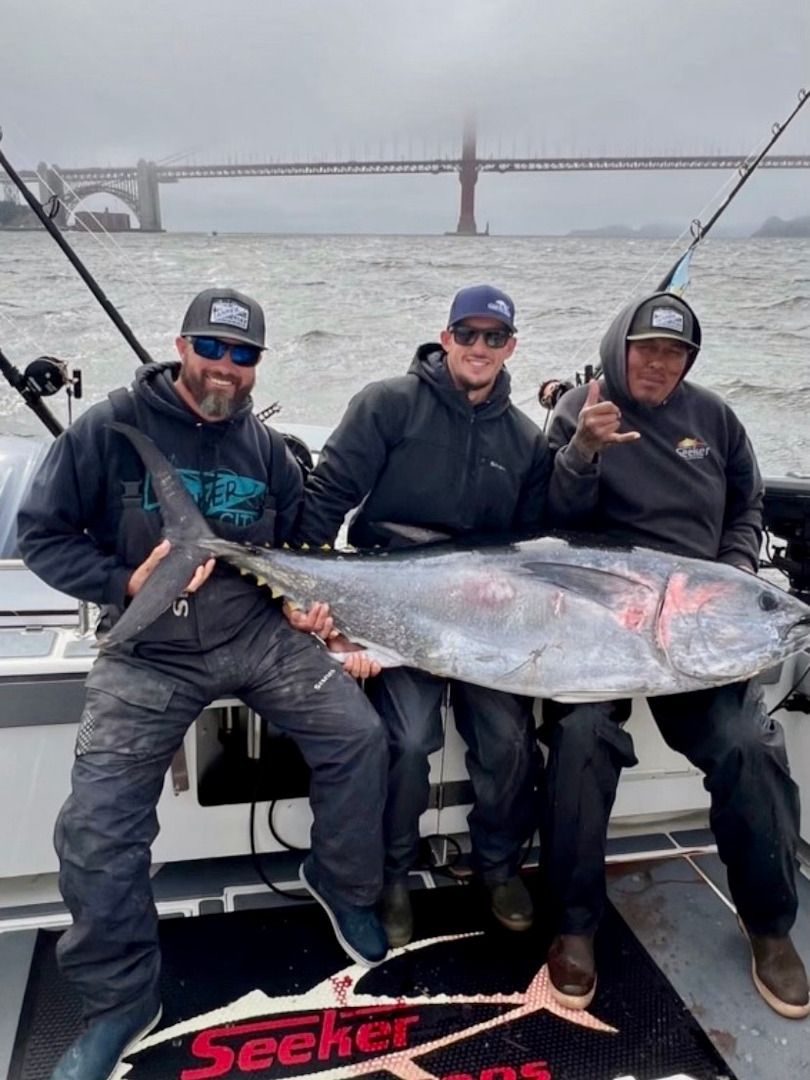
xmin=296 ymin=285 xmax=551 ymax=947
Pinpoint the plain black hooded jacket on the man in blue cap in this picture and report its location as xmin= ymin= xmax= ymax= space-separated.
xmin=296 ymin=345 xmax=551 ymax=548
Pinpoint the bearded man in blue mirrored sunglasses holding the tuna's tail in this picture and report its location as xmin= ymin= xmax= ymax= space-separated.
xmin=18 ymin=288 xmax=387 ymax=1080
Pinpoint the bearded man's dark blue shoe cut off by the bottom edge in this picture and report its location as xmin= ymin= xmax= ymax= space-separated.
xmin=51 ymin=998 xmax=162 ymax=1080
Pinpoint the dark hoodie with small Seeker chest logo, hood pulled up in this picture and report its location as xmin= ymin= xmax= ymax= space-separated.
xmin=549 ymin=297 xmax=764 ymax=569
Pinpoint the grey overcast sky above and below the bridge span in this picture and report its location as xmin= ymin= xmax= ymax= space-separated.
xmin=0 ymin=0 xmax=810 ymax=233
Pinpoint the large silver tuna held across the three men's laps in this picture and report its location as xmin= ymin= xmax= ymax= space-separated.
xmin=106 ymin=424 xmax=810 ymax=701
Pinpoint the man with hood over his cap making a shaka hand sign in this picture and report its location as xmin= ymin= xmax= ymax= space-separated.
xmin=541 ymin=293 xmax=810 ymax=1018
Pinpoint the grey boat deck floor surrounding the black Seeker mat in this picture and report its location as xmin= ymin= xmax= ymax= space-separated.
xmin=0 ymin=829 xmax=810 ymax=1080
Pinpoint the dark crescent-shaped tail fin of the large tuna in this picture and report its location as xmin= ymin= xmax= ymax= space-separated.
xmin=102 ymin=423 xmax=214 ymax=647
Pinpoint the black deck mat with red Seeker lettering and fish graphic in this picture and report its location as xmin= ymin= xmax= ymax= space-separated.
xmin=9 ymin=887 xmax=733 ymax=1080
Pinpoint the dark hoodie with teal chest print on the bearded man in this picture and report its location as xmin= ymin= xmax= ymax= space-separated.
xmin=17 ymin=363 xmax=301 ymax=648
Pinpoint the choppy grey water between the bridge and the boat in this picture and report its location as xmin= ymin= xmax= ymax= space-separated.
xmin=0 ymin=232 xmax=810 ymax=474
